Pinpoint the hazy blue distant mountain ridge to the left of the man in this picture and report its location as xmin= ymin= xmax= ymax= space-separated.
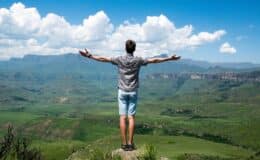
xmin=0 ymin=54 xmax=115 ymax=72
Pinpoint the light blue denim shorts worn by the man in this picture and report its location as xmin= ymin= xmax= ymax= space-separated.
xmin=118 ymin=89 xmax=137 ymax=116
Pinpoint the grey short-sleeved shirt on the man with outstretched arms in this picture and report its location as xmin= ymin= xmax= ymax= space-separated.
xmin=111 ymin=53 xmax=148 ymax=92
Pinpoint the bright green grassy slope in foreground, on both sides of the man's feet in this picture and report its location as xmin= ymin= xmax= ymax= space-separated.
xmin=69 ymin=135 xmax=254 ymax=159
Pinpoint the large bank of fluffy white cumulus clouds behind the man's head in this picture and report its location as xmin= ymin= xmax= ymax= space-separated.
xmin=0 ymin=3 xmax=226 ymax=59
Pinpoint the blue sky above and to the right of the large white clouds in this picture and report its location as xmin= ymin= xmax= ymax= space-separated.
xmin=0 ymin=0 xmax=260 ymax=63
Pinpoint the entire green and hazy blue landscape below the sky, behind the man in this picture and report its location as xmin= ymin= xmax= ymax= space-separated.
xmin=0 ymin=54 xmax=260 ymax=160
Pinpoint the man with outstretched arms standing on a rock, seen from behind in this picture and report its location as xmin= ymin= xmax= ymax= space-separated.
xmin=79 ymin=40 xmax=180 ymax=151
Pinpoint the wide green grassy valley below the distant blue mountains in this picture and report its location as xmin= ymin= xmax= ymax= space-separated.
xmin=0 ymin=71 xmax=260 ymax=160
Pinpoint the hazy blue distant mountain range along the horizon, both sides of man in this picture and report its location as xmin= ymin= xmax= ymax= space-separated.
xmin=0 ymin=54 xmax=260 ymax=75
